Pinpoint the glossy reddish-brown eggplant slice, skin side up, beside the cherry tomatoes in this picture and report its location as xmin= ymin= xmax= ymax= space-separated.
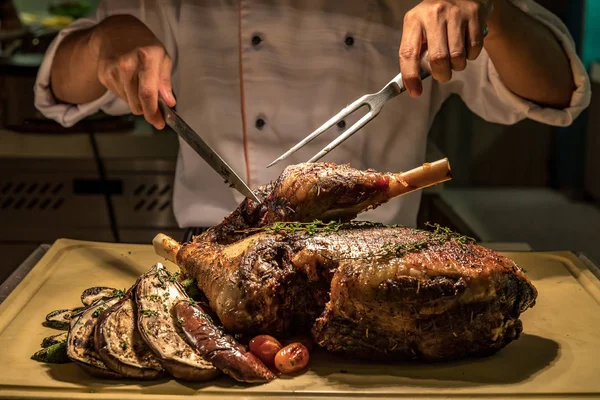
xmin=175 ymin=300 xmax=275 ymax=383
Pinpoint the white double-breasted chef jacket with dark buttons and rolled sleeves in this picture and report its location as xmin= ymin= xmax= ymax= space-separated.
xmin=35 ymin=0 xmax=590 ymax=227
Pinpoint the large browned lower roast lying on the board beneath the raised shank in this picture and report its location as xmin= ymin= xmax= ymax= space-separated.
xmin=178 ymin=223 xmax=537 ymax=359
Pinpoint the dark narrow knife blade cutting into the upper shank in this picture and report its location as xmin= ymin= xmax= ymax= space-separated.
xmin=158 ymin=97 xmax=260 ymax=203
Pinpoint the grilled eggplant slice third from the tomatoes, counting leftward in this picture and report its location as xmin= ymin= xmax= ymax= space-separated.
xmin=94 ymin=282 xmax=164 ymax=379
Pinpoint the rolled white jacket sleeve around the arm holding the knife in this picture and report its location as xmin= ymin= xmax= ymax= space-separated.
xmin=34 ymin=0 xmax=176 ymax=127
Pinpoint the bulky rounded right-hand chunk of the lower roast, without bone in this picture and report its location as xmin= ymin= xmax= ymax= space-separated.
xmin=313 ymin=228 xmax=537 ymax=361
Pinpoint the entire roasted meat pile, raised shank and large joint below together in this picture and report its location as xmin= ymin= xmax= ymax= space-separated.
xmin=155 ymin=163 xmax=537 ymax=360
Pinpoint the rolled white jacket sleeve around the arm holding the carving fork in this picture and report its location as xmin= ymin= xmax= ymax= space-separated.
xmin=434 ymin=0 xmax=591 ymax=127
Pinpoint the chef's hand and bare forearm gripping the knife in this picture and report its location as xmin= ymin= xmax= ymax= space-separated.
xmin=89 ymin=15 xmax=175 ymax=129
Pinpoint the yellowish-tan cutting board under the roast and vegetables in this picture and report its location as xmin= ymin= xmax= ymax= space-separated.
xmin=0 ymin=239 xmax=600 ymax=400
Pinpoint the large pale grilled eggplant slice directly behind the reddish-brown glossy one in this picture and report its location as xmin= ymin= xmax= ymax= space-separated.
xmin=135 ymin=263 xmax=221 ymax=381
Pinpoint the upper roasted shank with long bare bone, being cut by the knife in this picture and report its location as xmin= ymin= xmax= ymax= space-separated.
xmin=202 ymin=159 xmax=451 ymax=244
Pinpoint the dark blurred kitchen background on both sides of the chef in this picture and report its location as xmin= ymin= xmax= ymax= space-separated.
xmin=0 ymin=0 xmax=600 ymax=282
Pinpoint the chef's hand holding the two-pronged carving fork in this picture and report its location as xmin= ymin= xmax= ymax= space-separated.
xmin=399 ymin=0 xmax=493 ymax=97
